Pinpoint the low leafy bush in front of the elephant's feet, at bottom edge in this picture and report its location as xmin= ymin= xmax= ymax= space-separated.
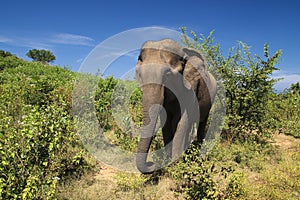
xmin=167 ymin=144 xmax=245 ymax=199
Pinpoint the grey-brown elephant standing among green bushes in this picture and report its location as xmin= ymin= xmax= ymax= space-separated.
xmin=135 ymin=39 xmax=217 ymax=174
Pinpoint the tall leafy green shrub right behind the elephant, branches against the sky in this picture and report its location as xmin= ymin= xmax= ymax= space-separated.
xmin=182 ymin=27 xmax=281 ymax=140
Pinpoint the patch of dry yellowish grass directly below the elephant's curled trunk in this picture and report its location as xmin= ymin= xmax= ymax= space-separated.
xmin=56 ymin=165 xmax=184 ymax=200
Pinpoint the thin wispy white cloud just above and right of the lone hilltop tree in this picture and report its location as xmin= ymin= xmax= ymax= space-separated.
xmin=50 ymin=33 xmax=94 ymax=46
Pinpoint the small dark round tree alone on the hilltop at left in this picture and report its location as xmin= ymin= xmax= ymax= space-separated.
xmin=26 ymin=49 xmax=56 ymax=64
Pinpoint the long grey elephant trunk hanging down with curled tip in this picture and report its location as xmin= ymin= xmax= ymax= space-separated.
xmin=136 ymin=84 xmax=164 ymax=174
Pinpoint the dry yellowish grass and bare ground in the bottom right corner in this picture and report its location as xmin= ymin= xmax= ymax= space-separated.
xmin=246 ymin=134 xmax=300 ymax=200
